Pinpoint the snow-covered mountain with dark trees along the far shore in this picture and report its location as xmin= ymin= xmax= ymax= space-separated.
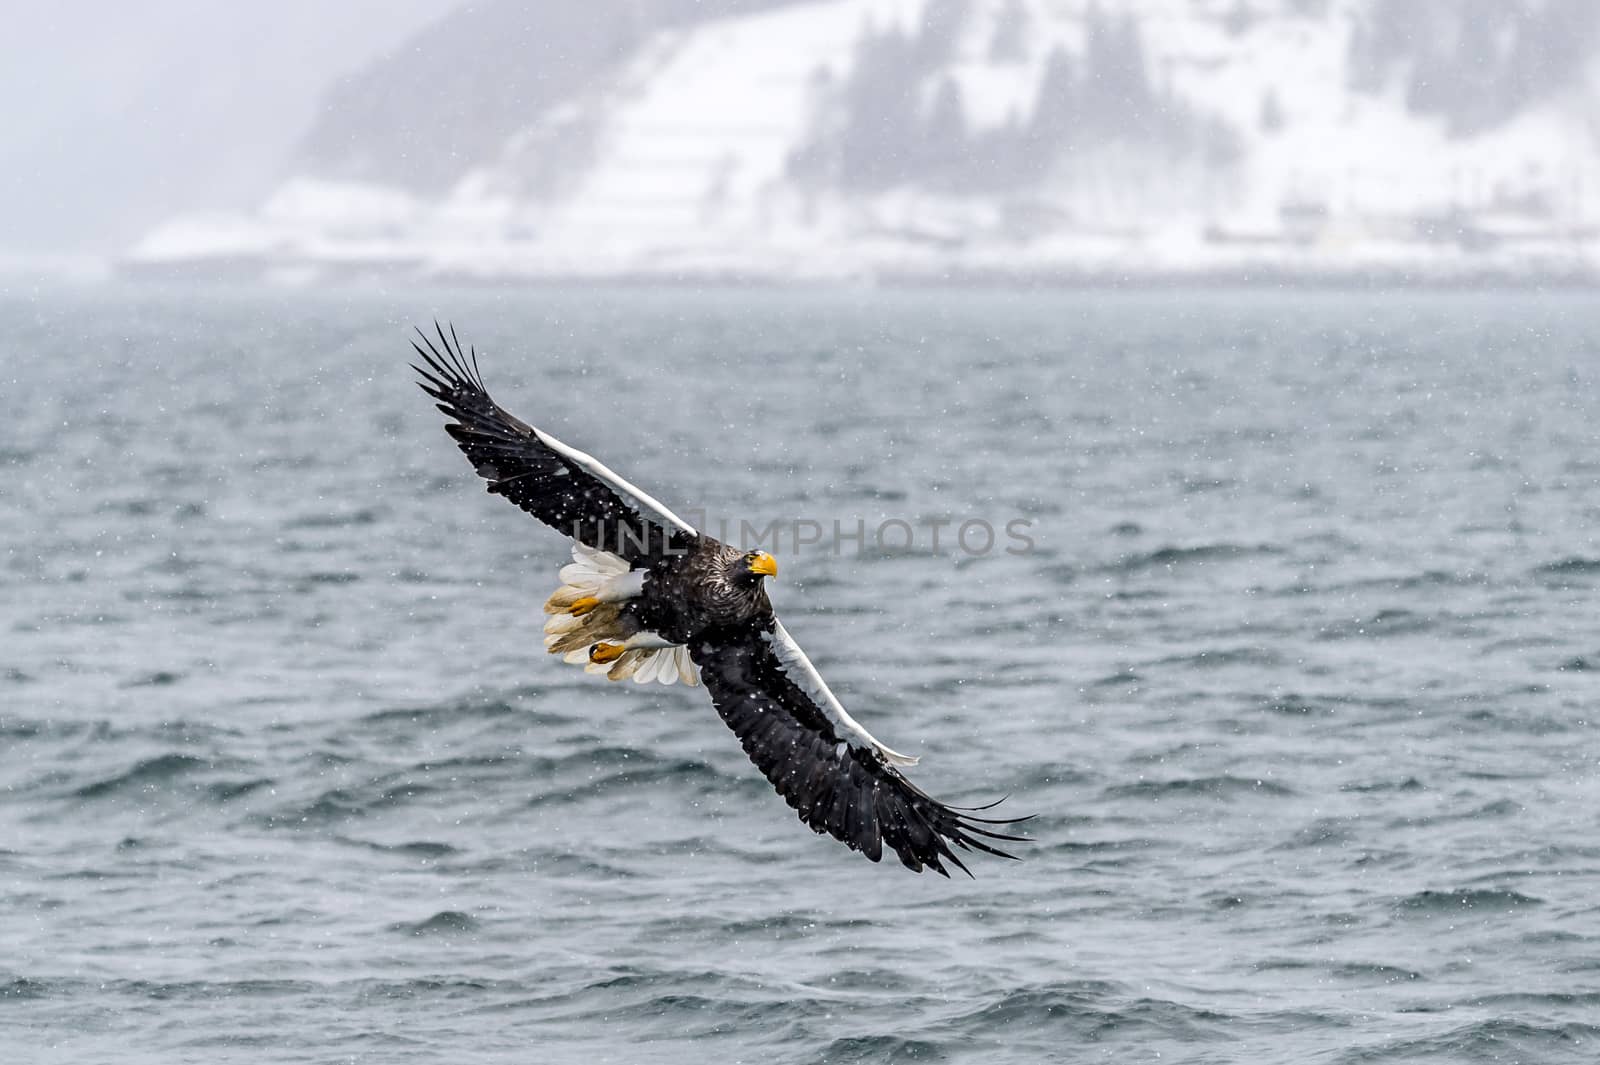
xmin=128 ymin=0 xmax=1600 ymax=278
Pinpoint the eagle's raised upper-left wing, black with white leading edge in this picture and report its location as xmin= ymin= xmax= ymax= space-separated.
xmin=411 ymin=321 xmax=699 ymax=563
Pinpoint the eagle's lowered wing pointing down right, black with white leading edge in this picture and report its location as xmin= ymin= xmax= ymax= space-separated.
xmin=690 ymin=620 xmax=1027 ymax=876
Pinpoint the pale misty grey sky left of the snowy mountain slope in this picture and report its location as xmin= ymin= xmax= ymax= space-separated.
xmin=0 ymin=0 xmax=459 ymax=256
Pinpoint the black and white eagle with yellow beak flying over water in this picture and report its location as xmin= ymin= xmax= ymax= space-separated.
xmin=411 ymin=321 xmax=1029 ymax=876
